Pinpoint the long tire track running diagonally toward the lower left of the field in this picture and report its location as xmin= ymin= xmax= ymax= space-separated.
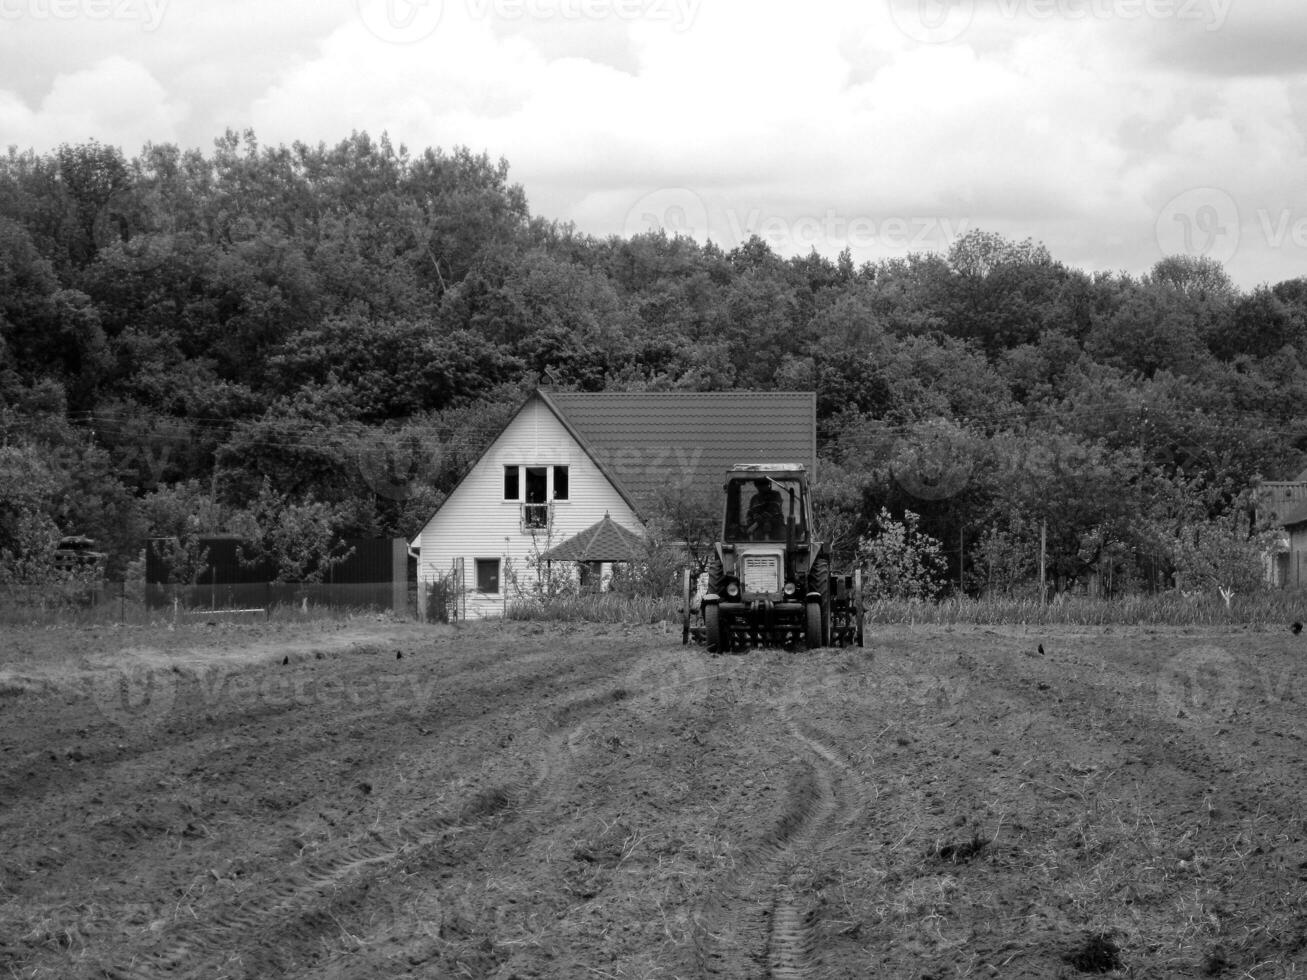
xmin=106 ymin=665 xmax=674 ymax=980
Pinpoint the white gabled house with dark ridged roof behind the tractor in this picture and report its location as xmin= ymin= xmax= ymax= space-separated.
xmin=412 ymin=389 xmax=817 ymax=618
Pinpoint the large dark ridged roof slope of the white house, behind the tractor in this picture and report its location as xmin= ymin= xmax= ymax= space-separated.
xmin=538 ymin=389 xmax=817 ymax=512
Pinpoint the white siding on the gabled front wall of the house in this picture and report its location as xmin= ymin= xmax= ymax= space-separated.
xmin=417 ymin=399 xmax=642 ymax=618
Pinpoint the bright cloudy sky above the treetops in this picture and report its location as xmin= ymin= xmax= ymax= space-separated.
xmin=0 ymin=0 xmax=1307 ymax=289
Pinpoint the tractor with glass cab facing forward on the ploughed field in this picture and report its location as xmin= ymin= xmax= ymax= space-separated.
xmin=682 ymin=463 xmax=863 ymax=653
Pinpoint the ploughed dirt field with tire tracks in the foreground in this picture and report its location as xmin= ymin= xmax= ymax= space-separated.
xmin=0 ymin=619 xmax=1307 ymax=980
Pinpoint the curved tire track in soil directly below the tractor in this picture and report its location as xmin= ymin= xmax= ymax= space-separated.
xmin=694 ymin=712 xmax=864 ymax=980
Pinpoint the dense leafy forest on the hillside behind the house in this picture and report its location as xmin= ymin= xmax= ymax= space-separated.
xmin=0 ymin=132 xmax=1307 ymax=592
